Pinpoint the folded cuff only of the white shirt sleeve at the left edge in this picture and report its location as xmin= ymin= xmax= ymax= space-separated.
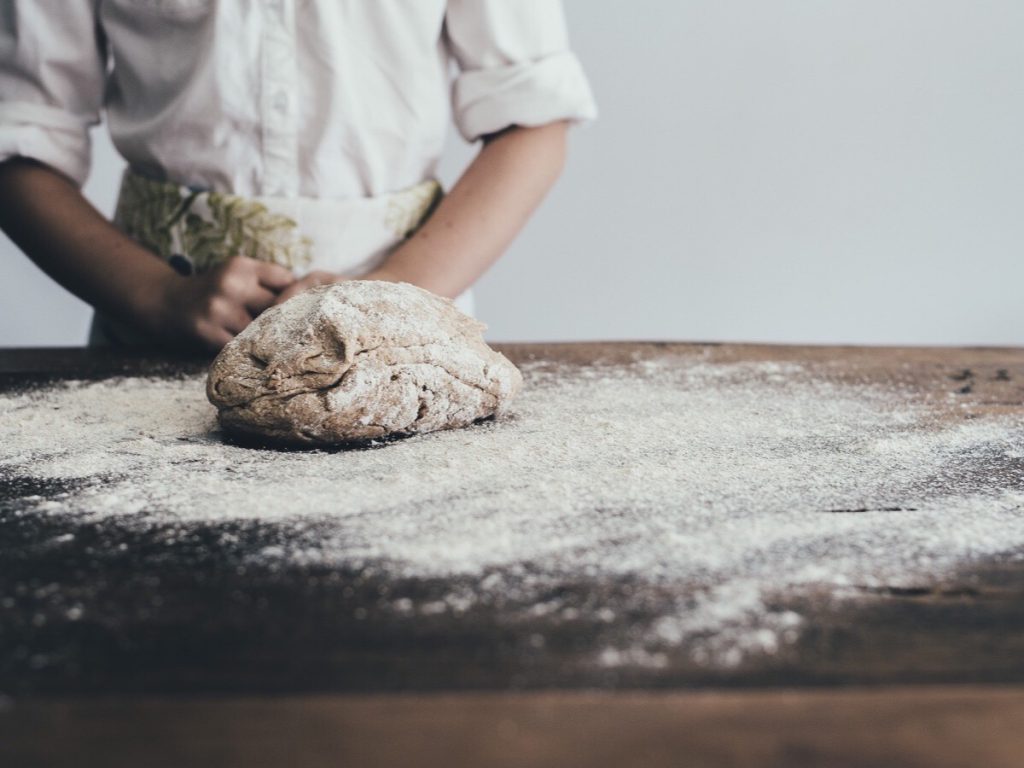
xmin=0 ymin=101 xmax=98 ymax=186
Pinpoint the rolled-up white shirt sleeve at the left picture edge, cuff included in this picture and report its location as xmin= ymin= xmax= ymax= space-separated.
xmin=0 ymin=0 xmax=106 ymax=185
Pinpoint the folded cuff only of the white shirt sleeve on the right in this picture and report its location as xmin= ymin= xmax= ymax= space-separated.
xmin=452 ymin=51 xmax=597 ymax=141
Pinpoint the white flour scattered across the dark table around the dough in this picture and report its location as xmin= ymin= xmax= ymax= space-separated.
xmin=0 ymin=359 xmax=1024 ymax=669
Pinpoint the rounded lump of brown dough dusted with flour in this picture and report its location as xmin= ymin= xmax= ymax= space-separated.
xmin=207 ymin=281 xmax=522 ymax=445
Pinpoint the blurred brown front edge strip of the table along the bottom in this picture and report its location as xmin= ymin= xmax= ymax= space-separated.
xmin=0 ymin=687 xmax=1024 ymax=768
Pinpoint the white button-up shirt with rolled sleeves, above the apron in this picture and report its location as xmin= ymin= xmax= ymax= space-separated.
xmin=0 ymin=0 xmax=596 ymax=198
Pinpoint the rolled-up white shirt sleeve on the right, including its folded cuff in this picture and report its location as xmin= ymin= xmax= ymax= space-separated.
xmin=444 ymin=0 xmax=597 ymax=141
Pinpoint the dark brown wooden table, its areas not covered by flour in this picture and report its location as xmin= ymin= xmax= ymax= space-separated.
xmin=0 ymin=343 xmax=1024 ymax=766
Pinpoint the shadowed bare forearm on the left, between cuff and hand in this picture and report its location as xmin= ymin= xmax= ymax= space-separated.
xmin=0 ymin=159 xmax=175 ymax=330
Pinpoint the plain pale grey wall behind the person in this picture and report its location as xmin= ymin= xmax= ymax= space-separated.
xmin=0 ymin=0 xmax=1024 ymax=345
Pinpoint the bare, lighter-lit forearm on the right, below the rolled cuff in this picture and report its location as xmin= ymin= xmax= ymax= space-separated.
xmin=383 ymin=123 xmax=567 ymax=297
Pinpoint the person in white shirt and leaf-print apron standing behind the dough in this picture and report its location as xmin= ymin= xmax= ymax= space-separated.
xmin=0 ymin=0 xmax=596 ymax=349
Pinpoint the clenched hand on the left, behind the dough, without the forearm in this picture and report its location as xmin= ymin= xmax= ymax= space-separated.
xmin=142 ymin=256 xmax=295 ymax=350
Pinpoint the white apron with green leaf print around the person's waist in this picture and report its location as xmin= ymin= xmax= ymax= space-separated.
xmin=89 ymin=169 xmax=473 ymax=346
